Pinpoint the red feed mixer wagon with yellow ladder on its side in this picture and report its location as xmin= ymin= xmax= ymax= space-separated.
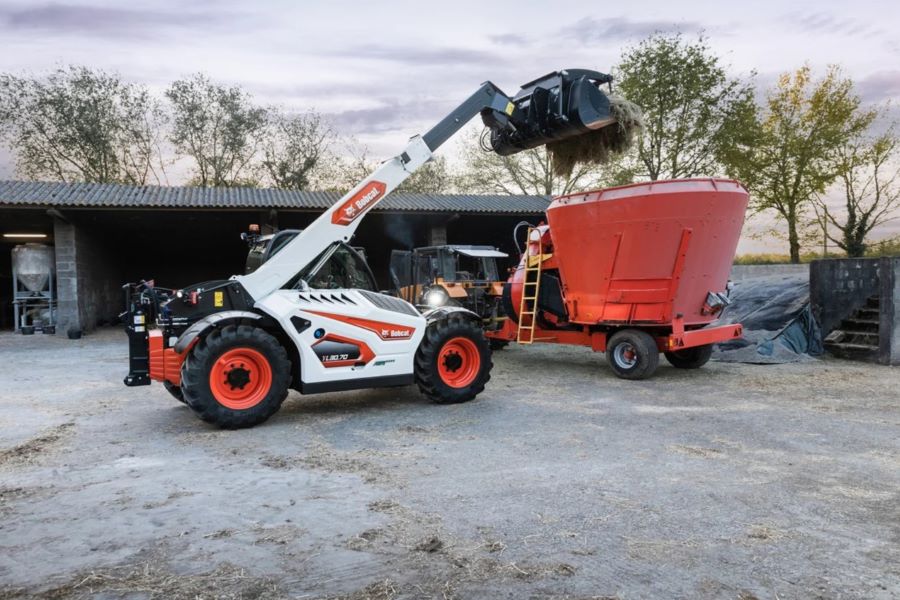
xmin=487 ymin=179 xmax=748 ymax=379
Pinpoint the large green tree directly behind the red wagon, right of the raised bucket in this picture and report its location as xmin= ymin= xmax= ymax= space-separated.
xmin=615 ymin=34 xmax=754 ymax=181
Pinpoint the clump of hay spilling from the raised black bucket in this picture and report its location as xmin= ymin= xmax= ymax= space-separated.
xmin=547 ymin=94 xmax=644 ymax=177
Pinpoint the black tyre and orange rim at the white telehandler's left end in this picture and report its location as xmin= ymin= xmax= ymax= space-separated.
xmin=181 ymin=325 xmax=291 ymax=429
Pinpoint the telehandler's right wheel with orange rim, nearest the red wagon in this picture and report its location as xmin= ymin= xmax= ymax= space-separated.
xmin=415 ymin=314 xmax=494 ymax=404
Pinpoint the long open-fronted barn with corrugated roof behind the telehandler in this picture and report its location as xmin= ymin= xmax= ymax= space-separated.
xmin=0 ymin=181 xmax=550 ymax=332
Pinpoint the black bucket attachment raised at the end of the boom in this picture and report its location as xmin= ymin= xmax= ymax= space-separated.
xmin=482 ymin=69 xmax=615 ymax=156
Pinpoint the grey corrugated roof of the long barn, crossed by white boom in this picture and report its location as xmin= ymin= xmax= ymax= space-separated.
xmin=0 ymin=181 xmax=550 ymax=215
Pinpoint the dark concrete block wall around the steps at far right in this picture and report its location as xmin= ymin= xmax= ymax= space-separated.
xmin=809 ymin=258 xmax=900 ymax=365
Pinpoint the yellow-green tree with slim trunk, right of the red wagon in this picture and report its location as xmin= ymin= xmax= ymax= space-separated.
xmin=722 ymin=66 xmax=875 ymax=263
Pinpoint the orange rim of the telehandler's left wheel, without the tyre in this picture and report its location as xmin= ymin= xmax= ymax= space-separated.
xmin=209 ymin=348 xmax=272 ymax=410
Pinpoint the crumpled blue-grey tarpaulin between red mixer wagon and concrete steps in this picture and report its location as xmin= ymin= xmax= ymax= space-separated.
xmin=713 ymin=275 xmax=823 ymax=364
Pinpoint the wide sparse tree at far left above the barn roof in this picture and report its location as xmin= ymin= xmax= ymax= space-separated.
xmin=0 ymin=66 xmax=165 ymax=185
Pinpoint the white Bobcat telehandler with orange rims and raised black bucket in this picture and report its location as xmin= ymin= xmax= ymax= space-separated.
xmin=125 ymin=69 xmax=615 ymax=428
